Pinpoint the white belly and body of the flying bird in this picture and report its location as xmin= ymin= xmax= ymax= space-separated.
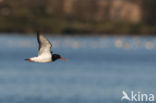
xmin=30 ymin=53 xmax=52 ymax=63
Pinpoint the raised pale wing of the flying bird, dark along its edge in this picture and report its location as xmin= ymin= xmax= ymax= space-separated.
xmin=37 ymin=33 xmax=52 ymax=56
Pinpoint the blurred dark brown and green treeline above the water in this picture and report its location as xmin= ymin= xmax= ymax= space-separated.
xmin=0 ymin=0 xmax=156 ymax=34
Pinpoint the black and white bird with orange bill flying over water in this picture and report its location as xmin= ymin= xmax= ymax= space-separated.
xmin=25 ymin=32 xmax=67 ymax=63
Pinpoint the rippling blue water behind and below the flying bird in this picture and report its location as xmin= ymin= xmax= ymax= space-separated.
xmin=0 ymin=34 xmax=156 ymax=103
